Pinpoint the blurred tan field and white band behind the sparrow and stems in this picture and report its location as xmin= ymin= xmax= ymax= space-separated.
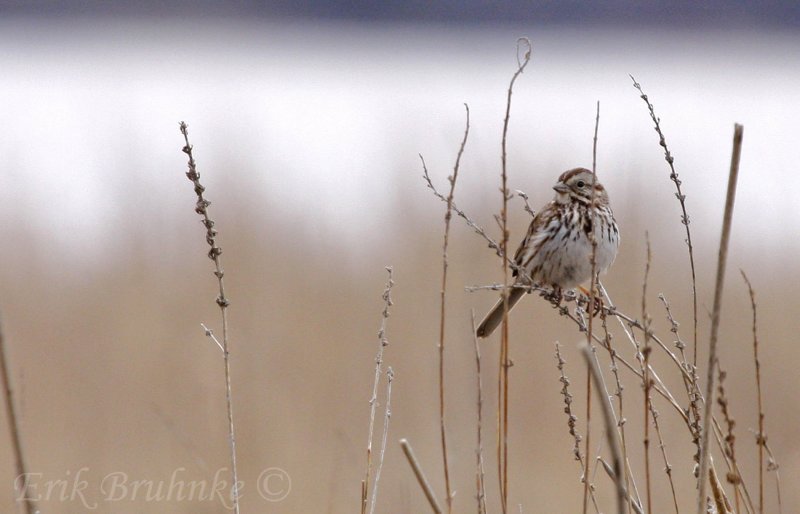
xmin=0 ymin=5 xmax=800 ymax=513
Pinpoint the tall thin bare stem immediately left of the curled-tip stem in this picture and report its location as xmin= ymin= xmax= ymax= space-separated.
xmin=434 ymin=104 xmax=469 ymax=512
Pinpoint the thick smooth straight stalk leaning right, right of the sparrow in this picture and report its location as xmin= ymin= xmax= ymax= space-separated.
xmin=697 ymin=123 xmax=744 ymax=514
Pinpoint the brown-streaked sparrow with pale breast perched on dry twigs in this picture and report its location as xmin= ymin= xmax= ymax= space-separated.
xmin=477 ymin=168 xmax=619 ymax=337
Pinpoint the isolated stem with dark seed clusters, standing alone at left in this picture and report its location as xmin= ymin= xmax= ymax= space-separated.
xmin=180 ymin=122 xmax=239 ymax=514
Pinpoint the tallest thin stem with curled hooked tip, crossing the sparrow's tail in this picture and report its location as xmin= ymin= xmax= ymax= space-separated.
xmin=497 ymin=38 xmax=533 ymax=513
